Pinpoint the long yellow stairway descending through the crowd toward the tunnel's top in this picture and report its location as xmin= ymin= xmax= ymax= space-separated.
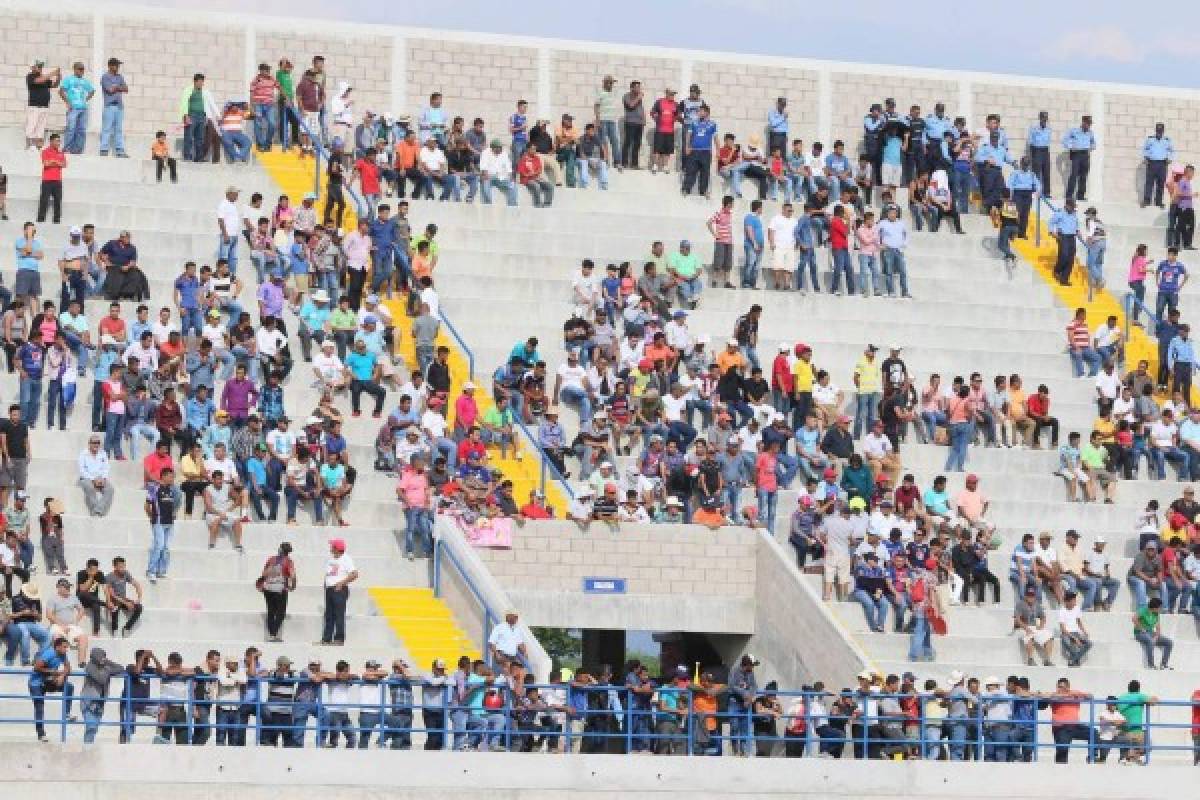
xmin=256 ymin=149 xmax=568 ymax=517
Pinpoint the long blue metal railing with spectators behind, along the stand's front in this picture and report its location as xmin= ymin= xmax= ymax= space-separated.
xmin=0 ymin=669 xmax=1200 ymax=764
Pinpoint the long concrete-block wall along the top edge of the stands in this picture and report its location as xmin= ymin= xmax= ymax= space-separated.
xmin=0 ymin=0 xmax=1200 ymax=201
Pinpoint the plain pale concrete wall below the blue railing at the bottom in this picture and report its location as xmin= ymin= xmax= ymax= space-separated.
xmin=5 ymin=742 xmax=1194 ymax=800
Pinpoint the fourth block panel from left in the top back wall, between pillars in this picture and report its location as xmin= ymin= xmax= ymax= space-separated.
xmin=408 ymin=38 xmax=535 ymax=134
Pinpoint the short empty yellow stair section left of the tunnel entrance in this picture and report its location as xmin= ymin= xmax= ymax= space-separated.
xmin=368 ymin=587 xmax=480 ymax=670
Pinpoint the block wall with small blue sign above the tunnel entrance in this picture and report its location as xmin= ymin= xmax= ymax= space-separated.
xmin=478 ymin=522 xmax=756 ymax=633
